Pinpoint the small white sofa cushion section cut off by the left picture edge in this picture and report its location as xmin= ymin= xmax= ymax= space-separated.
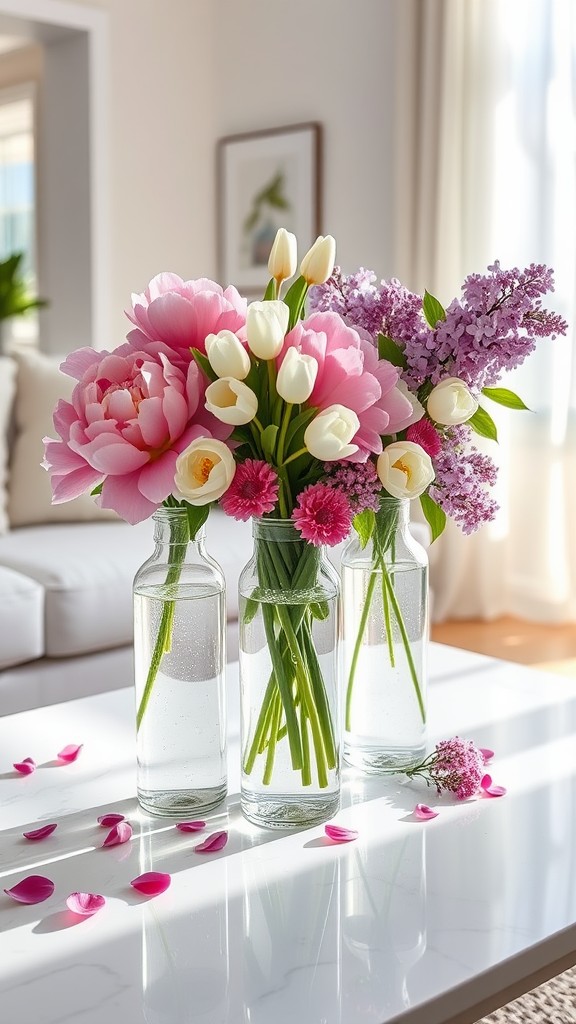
xmin=0 ymin=565 xmax=44 ymax=669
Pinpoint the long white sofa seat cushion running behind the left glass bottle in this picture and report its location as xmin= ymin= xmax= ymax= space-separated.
xmin=0 ymin=509 xmax=251 ymax=657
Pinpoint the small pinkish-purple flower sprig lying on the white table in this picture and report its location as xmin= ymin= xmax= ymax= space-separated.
xmin=404 ymin=736 xmax=485 ymax=800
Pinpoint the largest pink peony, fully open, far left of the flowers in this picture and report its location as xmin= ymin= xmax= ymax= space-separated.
xmin=44 ymin=345 xmax=231 ymax=523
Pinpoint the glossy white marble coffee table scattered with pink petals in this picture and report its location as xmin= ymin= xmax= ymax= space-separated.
xmin=0 ymin=645 xmax=576 ymax=1024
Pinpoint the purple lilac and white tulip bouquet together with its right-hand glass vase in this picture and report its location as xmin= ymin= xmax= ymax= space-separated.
xmin=311 ymin=262 xmax=567 ymax=771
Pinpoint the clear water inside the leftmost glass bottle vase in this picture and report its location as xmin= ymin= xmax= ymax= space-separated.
xmin=134 ymin=584 xmax=227 ymax=816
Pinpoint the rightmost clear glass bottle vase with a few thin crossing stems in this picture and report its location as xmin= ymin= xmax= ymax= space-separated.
xmin=342 ymin=498 xmax=428 ymax=772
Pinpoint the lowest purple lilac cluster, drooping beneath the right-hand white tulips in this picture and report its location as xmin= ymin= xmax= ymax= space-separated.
xmin=428 ymin=424 xmax=498 ymax=534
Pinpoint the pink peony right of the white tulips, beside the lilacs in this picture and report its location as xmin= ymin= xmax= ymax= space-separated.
xmin=278 ymin=312 xmax=413 ymax=462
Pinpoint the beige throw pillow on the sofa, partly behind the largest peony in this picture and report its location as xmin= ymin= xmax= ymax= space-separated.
xmin=8 ymin=350 xmax=118 ymax=526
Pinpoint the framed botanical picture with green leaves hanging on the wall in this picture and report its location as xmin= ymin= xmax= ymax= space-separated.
xmin=217 ymin=122 xmax=322 ymax=298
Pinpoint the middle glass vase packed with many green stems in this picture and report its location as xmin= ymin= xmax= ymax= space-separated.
xmin=240 ymin=519 xmax=340 ymax=828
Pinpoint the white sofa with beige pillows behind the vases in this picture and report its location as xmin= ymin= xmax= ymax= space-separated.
xmin=0 ymin=352 xmax=425 ymax=715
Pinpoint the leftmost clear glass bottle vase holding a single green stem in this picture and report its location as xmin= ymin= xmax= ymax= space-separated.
xmin=134 ymin=507 xmax=227 ymax=816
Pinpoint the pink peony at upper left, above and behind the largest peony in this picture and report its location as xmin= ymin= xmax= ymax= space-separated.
xmin=126 ymin=273 xmax=247 ymax=369
